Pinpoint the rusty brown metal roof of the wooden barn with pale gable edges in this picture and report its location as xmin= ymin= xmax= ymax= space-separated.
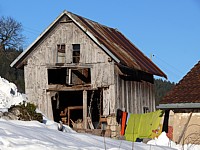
xmin=11 ymin=11 xmax=167 ymax=78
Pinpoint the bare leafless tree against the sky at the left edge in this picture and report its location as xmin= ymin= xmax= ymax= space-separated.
xmin=0 ymin=17 xmax=24 ymax=50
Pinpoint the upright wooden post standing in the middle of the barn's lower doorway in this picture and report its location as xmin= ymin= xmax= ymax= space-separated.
xmin=83 ymin=90 xmax=87 ymax=129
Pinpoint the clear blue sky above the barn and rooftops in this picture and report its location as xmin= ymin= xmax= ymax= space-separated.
xmin=0 ymin=0 xmax=200 ymax=83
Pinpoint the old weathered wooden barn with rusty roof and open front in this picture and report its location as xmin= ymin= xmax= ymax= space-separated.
xmin=11 ymin=11 xmax=166 ymax=128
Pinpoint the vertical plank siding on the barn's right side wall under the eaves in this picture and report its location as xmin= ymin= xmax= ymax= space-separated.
xmin=115 ymin=72 xmax=155 ymax=113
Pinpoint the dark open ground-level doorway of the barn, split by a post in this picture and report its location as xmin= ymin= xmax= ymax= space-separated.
xmin=51 ymin=89 xmax=102 ymax=128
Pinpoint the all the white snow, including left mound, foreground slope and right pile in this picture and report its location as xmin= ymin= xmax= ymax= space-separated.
xmin=0 ymin=77 xmax=200 ymax=150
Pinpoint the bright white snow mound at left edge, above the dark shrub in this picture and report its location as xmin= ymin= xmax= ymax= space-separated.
xmin=0 ymin=77 xmax=26 ymax=110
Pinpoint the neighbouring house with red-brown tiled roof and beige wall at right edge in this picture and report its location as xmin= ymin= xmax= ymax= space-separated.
xmin=157 ymin=61 xmax=200 ymax=144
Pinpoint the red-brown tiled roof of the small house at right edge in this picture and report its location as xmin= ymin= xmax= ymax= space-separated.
xmin=160 ymin=61 xmax=200 ymax=104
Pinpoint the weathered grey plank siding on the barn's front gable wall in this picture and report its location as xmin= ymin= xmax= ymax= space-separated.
xmin=24 ymin=17 xmax=114 ymax=117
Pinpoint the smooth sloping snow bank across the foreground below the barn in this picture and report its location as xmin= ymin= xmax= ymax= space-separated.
xmin=0 ymin=119 xmax=175 ymax=150
